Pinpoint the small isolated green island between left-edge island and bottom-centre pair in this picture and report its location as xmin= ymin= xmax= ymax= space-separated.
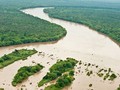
xmin=12 ymin=64 xmax=43 ymax=86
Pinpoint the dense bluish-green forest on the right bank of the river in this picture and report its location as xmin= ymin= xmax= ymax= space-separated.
xmin=44 ymin=7 xmax=120 ymax=43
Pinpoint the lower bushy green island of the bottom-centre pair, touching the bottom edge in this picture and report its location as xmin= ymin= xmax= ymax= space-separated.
xmin=45 ymin=74 xmax=74 ymax=90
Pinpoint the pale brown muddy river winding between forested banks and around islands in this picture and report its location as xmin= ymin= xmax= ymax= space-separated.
xmin=0 ymin=8 xmax=120 ymax=90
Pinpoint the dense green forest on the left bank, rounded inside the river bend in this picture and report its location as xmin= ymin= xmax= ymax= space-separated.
xmin=0 ymin=6 xmax=66 ymax=46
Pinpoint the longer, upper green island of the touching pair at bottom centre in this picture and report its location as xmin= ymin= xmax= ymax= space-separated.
xmin=38 ymin=58 xmax=77 ymax=87
